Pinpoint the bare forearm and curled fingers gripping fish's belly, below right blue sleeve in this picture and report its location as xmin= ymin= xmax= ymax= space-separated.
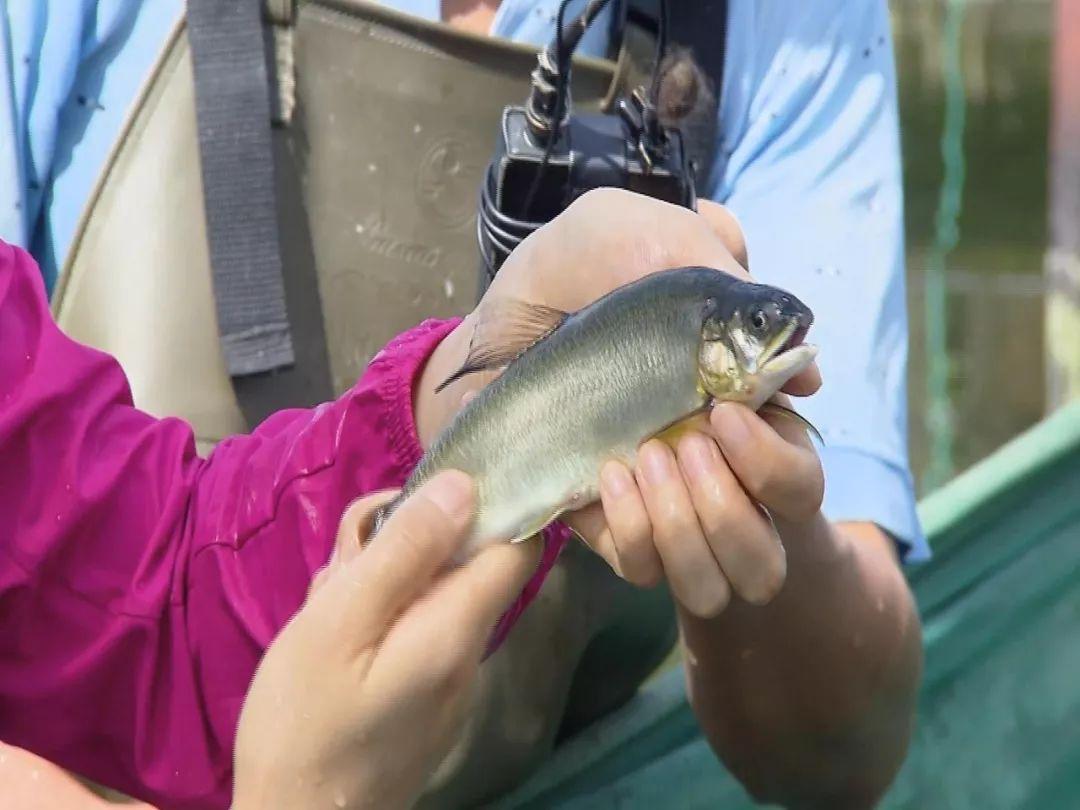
xmin=582 ymin=405 xmax=921 ymax=808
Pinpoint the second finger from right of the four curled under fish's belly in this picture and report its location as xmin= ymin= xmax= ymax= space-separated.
xmin=678 ymin=433 xmax=787 ymax=605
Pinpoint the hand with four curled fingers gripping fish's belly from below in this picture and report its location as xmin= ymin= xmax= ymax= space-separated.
xmin=565 ymin=403 xmax=824 ymax=618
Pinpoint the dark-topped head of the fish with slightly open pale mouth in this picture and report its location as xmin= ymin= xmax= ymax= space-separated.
xmin=699 ymin=281 xmax=818 ymax=408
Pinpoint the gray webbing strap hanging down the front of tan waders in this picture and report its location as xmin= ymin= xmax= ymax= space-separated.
xmin=188 ymin=0 xmax=294 ymax=376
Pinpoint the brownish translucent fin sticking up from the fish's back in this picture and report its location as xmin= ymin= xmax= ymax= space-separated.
xmin=435 ymin=298 xmax=569 ymax=393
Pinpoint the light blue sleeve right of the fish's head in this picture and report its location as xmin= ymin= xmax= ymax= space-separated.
xmin=710 ymin=0 xmax=930 ymax=563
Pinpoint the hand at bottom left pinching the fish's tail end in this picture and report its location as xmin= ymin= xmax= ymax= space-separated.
xmin=233 ymin=472 xmax=540 ymax=810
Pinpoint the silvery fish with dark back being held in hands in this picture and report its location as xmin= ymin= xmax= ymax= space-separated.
xmin=374 ymin=267 xmax=818 ymax=562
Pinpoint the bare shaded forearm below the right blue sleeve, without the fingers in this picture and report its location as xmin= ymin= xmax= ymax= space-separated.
xmin=679 ymin=517 xmax=922 ymax=808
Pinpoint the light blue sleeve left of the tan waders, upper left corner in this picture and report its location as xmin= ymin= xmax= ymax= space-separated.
xmin=0 ymin=0 xmax=184 ymax=287
